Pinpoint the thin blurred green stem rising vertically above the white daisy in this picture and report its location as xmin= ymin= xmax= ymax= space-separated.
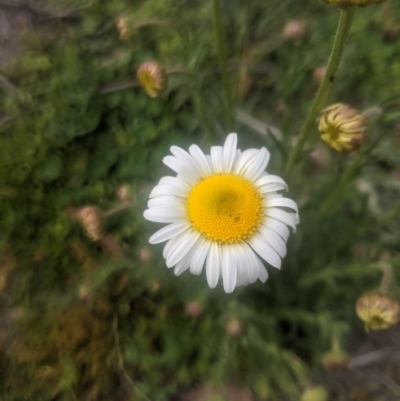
xmin=213 ymin=0 xmax=233 ymax=129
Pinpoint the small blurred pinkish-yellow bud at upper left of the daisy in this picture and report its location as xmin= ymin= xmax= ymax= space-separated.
xmin=136 ymin=61 xmax=167 ymax=97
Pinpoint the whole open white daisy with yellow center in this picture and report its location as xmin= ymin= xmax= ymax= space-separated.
xmin=144 ymin=134 xmax=299 ymax=293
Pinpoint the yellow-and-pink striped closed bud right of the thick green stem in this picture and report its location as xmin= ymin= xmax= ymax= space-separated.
xmin=318 ymin=103 xmax=365 ymax=152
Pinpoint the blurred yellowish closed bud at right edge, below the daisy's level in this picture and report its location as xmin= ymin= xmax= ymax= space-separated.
xmin=356 ymin=293 xmax=400 ymax=330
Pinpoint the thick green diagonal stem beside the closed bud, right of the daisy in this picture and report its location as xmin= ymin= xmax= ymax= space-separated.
xmin=285 ymin=7 xmax=355 ymax=175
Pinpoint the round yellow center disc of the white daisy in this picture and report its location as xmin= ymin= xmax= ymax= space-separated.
xmin=187 ymin=174 xmax=263 ymax=244
